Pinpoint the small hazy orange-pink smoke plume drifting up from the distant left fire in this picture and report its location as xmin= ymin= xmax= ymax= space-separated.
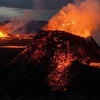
xmin=0 ymin=10 xmax=32 ymax=34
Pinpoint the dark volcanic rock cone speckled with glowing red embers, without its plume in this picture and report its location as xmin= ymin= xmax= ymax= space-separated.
xmin=0 ymin=31 xmax=100 ymax=95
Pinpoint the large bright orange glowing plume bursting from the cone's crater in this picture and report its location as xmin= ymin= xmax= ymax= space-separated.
xmin=43 ymin=0 xmax=100 ymax=37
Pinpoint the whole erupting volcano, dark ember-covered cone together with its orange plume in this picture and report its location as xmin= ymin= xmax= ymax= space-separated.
xmin=2 ymin=0 xmax=100 ymax=95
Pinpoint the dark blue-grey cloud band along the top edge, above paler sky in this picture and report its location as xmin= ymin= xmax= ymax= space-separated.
xmin=0 ymin=0 xmax=73 ymax=9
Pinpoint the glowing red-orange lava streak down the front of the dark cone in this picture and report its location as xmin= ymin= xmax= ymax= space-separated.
xmin=48 ymin=53 xmax=73 ymax=90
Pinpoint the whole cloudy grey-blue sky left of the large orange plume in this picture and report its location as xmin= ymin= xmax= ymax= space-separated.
xmin=0 ymin=0 xmax=73 ymax=21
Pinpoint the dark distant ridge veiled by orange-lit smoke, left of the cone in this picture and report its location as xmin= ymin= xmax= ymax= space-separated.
xmin=0 ymin=19 xmax=47 ymax=34
